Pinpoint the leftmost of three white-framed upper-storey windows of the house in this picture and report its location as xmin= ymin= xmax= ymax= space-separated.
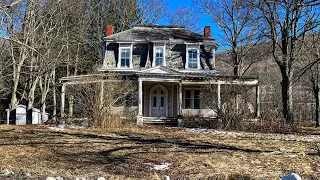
xmin=118 ymin=44 xmax=132 ymax=68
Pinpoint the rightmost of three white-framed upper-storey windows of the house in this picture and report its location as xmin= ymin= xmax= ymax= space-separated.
xmin=186 ymin=46 xmax=200 ymax=69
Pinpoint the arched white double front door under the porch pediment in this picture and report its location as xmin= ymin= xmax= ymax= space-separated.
xmin=151 ymin=86 xmax=167 ymax=117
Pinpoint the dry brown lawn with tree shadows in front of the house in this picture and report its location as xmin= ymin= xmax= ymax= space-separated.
xmin=0 ymin=126 xmax=320 ymax=179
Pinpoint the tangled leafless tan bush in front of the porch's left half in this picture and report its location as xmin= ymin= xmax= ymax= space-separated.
xmin=67 ymin=74 xmax=137 ymax=128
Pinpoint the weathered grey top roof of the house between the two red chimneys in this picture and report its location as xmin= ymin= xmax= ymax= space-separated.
xmin=104 ymin=25 xmax=218 ymax=47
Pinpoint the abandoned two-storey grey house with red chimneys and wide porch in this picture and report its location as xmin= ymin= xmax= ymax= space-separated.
xmin=60 ymin=25 xmax=259 ymax=124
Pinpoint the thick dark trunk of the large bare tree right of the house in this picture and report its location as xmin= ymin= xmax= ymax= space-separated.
xmin=280 ymin=66 xmax=293 ymax=124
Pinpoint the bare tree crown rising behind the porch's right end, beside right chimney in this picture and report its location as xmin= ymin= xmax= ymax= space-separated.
xmin=194 ymin=0 xmax=262 ymax=77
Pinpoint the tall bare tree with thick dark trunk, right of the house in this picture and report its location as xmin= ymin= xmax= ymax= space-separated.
xmin=252 ymin=0 xmax=320 ymax=123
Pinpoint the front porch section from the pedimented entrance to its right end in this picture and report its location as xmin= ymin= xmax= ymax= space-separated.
xmin=137 ymin=74 xmax=260 ymax=124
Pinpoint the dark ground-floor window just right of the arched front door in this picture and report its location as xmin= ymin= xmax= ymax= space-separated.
xmin=184 ymin=89 xmax=200 ymax=109
